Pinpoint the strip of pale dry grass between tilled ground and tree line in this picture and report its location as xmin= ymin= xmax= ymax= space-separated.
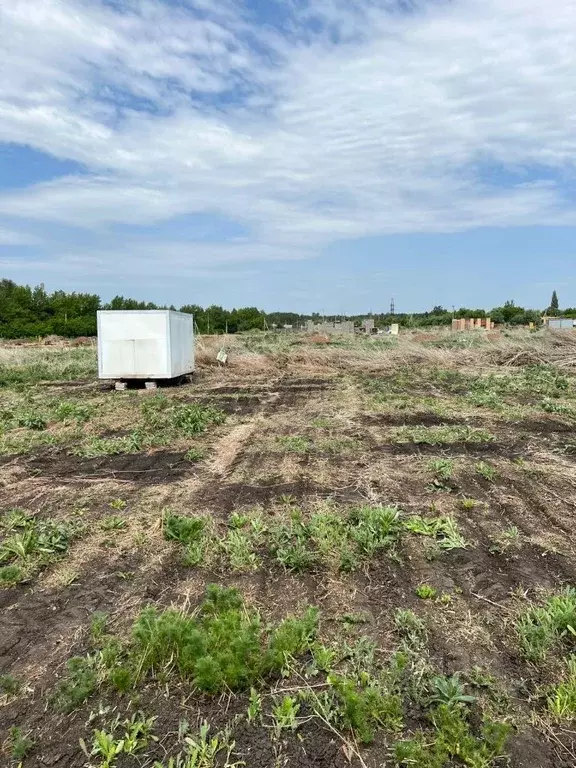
xmin=0 ymin=329 xmax=576 ymax=384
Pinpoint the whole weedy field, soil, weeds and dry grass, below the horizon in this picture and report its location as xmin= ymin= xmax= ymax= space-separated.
xmin=0 ymin=332 xmax=576 ymax=768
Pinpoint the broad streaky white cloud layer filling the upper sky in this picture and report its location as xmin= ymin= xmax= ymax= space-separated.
xmin=0 ymin=0 xmax=576 ymax=280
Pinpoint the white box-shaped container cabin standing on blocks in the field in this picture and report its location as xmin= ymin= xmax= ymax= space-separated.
xmin=98 ymin=309 xmax=194 ymax=382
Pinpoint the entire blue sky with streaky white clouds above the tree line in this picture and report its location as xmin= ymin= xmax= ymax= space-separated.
xmin=0 ymin=0 xmax=576 ymax=312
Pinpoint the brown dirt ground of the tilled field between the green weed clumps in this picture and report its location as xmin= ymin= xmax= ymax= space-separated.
xmin=0 ymin=338 xmax=576 ymax=768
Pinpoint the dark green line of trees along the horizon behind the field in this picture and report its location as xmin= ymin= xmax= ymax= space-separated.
xmin=0 ymin=280 xmax=576 ymax=339
